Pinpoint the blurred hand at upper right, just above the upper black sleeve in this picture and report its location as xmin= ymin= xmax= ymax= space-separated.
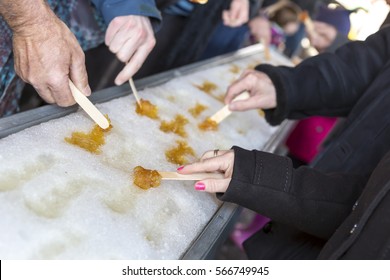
xmin=308 ymin=21 xmax=337 ymax=52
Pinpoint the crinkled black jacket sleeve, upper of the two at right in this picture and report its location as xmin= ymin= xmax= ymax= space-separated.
xmin=256 ymin=28 xmax=390 ymax=125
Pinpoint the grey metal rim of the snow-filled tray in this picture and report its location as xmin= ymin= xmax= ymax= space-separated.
xmin=0 ymin=42 xmax=293 ymax=259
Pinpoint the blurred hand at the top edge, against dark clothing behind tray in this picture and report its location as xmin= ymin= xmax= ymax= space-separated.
xmin=222 ymin=0 xmax=249 ymax=27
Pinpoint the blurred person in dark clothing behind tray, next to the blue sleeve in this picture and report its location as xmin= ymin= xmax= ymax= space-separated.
xmin=135 ymin=0 xmax=259 ymax=78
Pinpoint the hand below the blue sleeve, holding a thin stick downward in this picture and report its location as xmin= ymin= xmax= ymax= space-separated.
xmin=105 ymin=15 xmax=156 ymax=85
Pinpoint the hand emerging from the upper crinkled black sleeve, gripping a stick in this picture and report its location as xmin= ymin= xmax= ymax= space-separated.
xmin=225 ymin=70 xmax=277 ymax=111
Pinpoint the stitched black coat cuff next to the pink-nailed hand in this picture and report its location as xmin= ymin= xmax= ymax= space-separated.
xmin=217 ymin=146 xmax=293 ymax=214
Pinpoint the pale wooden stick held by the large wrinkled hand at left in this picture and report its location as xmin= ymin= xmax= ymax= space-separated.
xmin=69 ymin=80 xmax=110 ymax=129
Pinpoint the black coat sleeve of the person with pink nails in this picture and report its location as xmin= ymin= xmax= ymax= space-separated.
xmin=217 ymin=147 xmax=368 ymax=238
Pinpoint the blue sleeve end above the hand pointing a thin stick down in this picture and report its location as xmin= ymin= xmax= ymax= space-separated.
xmin=92 ymin=0 xmax=161 ymax=31
